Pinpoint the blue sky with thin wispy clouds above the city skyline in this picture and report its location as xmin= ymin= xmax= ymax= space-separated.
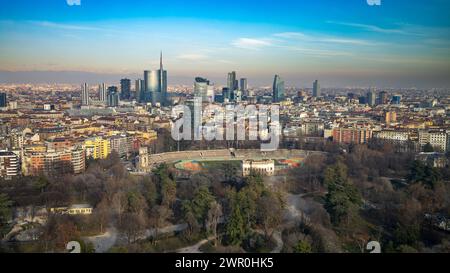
xmin=0 ymin=0 xmax=450 ymax=88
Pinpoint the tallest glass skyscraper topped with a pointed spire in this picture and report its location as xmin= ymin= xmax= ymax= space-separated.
xmin=144 ymin=52 xmax=167 ymax=105
